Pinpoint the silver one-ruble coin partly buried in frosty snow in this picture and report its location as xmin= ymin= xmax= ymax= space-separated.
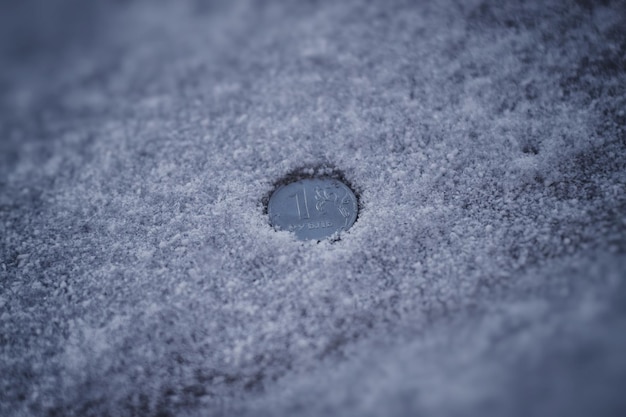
xmin=268 ymin=178 xmax=358 ymax=240
